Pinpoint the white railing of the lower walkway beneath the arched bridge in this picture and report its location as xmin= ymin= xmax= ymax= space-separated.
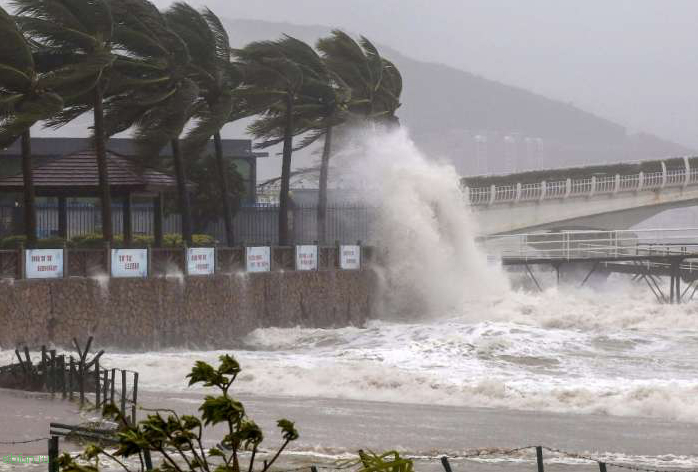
xmin=478 ymin=228 xmax=698 ymax=261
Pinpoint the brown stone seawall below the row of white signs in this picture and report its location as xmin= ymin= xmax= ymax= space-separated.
xmin=0 ymin=270 xmax=377 ymax=350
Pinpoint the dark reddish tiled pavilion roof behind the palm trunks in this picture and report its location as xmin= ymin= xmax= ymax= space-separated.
xmin=0 ymin=150 xmax=182 ymax=191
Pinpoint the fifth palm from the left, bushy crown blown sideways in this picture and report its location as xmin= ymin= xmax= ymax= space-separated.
xmin=235 ymin=36 xmax=324 ymax=245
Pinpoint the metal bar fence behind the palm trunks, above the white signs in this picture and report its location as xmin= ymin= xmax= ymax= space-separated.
xmin=0 ymin=203 xmax=376 ymax=245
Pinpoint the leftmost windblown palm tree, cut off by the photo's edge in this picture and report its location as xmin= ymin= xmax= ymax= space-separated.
xmin=0 ymin=8 xmax=63 ymax=247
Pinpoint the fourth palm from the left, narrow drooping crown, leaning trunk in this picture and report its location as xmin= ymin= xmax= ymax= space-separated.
xmin=165 ymin=2 xmax=242 ymax=246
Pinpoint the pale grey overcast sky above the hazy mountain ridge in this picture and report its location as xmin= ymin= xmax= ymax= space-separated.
xmin=143 ymin=0 xmax=698 ymax=147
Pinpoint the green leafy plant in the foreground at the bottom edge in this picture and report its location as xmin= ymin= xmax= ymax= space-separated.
xmin=58 ymin=355 xmax=298 ymax=472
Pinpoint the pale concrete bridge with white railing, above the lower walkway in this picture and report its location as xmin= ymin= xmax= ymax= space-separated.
xmin=462 ymin=157 xmax=698 ymax=235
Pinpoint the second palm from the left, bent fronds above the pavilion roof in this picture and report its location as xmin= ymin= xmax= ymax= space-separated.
xmin=12 ymin=0 xmax=115 ymax=241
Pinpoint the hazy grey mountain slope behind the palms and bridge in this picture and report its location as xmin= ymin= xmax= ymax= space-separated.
xmin=225 ymin=19 xmax=692 ymax=174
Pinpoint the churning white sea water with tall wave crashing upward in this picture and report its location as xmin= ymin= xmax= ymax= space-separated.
xmin=0 ymin=130 xmax=698 ymax=470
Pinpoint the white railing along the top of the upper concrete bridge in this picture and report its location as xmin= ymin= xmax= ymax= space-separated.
xmin=464 ymin=159 xmax=698 ymax=206
